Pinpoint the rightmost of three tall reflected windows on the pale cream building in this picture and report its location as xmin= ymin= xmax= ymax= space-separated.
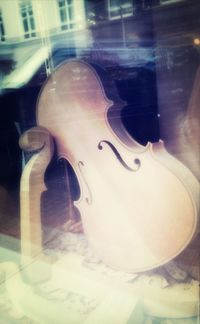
xmin=58 ymin=0 xmax=75 ymax=30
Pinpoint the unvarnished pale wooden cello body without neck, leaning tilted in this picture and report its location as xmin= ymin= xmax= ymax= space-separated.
xmin=37 ymin=60 xmax=199 ymax=272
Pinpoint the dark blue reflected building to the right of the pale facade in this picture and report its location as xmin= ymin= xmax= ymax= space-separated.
xmin=86 ymin=0 xmax=200 ymax=46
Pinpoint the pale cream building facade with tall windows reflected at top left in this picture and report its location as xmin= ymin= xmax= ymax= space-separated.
xmin=0 ymin=0 xmax=85 ymax=43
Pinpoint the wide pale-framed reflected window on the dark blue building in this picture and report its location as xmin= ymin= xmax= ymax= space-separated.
xmin=108 ymin=0 xmax=133 ymax=19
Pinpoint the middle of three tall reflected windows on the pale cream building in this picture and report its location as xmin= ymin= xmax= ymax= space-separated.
xmin=20 ymin=0 xmax=36 ymax=38
